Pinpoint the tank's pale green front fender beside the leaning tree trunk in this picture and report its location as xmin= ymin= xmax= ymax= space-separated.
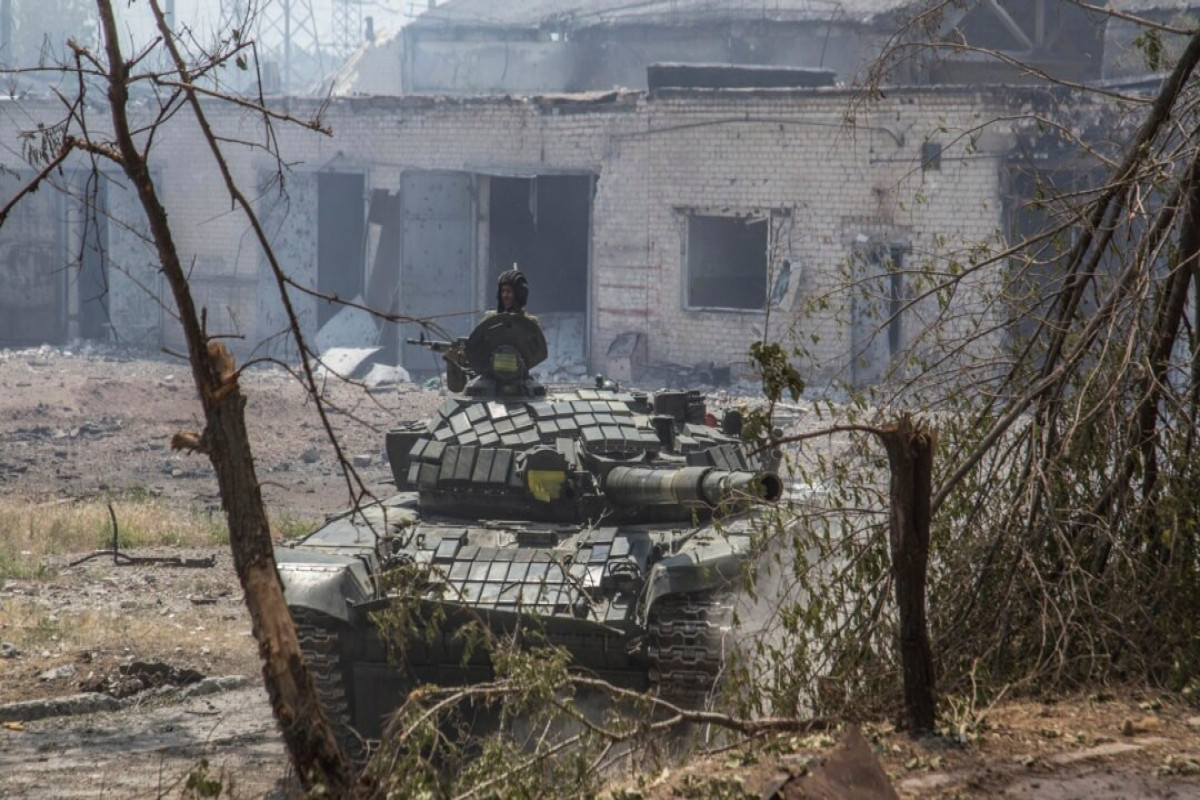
xmin=275 ymin=549 xmax=374 ymax=622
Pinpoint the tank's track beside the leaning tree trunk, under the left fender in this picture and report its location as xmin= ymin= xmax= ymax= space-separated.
xmin=290 ymin=608 xmax=367 ymax=765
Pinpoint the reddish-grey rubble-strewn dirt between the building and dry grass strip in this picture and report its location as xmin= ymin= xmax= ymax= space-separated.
xmin=0 ymin=347 xmax=440 ymax=518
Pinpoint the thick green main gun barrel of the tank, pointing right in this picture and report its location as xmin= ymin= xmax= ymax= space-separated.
xmin=604 ymin=467 xmax=784 ymax=507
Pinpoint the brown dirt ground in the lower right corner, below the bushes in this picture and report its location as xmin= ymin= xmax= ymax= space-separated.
xmin=628 ymin=692 xmax=1200 ymax=800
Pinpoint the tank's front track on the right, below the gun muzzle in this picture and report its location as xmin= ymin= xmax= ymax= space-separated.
xmin=647 ymin=593 xmax=733 ymax=709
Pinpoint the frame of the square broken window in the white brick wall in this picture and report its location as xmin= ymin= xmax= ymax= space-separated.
xmin=676 ymin=207 xmax=792 ymax=314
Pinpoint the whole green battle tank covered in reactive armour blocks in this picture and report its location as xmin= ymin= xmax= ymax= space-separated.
xmin=276 ymin=313 xmax=782 ymax=745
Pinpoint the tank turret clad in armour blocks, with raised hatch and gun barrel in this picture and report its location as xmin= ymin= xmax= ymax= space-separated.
xmin=388 ymin=314 xmax=782 ymax=524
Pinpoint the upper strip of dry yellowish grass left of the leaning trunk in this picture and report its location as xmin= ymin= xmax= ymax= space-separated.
xmin=0 ymin=492 xmax=229 ymax=582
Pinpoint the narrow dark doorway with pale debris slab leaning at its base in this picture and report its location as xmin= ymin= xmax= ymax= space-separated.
xmin=317 ymin=173 xmax=366 ymax=326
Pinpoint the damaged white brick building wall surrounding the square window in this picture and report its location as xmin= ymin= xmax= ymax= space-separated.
xmin=0 ymin=90 xmax=1004 ymax=378
